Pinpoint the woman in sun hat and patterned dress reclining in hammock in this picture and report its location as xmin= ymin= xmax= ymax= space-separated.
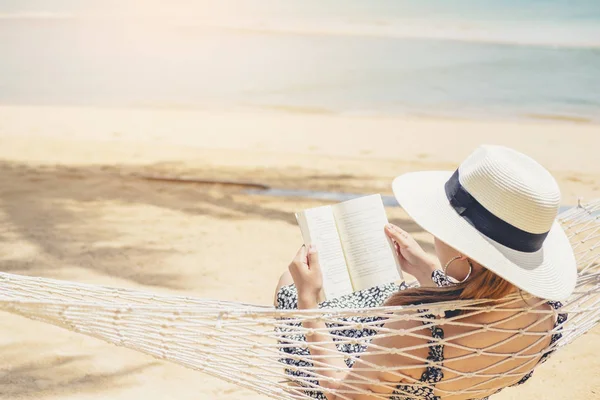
xmin=276 ymin=146 xmax=576 ymax=400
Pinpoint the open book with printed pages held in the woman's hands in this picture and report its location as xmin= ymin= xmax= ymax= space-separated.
xmin=296 ymin=194 xmax=402 ymax=299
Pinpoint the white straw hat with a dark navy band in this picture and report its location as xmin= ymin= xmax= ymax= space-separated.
xmin=392 ymin=146 xmax=577 ymax=300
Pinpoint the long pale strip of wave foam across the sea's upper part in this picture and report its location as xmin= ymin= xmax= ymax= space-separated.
xmin=0 ymin=12 xmax=600 ymax=48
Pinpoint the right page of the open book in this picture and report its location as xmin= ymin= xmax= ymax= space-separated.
xmin=332 ymin=194 xmax=401 ymax=291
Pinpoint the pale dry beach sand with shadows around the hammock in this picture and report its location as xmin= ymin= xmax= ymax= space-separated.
xmin=0 ymin=107 xmax=600 ymax=400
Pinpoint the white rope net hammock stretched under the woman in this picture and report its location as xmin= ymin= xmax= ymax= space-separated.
xmin=0 ymin=200 xmax=600 ymax=399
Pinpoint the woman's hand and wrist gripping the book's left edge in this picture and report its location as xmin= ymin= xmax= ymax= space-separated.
xmin=288 ymin=245 xmax=323 ymax=308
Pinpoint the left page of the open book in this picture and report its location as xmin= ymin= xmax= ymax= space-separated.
xmin=296 ymin=206 xmax=353 ymax=299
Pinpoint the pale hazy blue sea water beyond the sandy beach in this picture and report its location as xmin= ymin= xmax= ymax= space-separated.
xmin=0 ymin=0 xmax=600 ymax=122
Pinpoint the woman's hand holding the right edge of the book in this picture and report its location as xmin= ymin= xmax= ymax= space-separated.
xmin=385 ymin=224 xmax=441 ymax=286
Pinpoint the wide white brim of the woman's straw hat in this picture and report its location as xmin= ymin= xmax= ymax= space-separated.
xmin=392 ymin=171 xmax=577 ymax=300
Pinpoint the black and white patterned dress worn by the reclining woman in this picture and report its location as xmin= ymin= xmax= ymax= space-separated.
xmin=277 ymin=270 xmax=567 ymax=400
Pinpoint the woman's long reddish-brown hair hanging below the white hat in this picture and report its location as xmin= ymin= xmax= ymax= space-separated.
xmin=385 ymin=268 xmax=515 ymax=306
